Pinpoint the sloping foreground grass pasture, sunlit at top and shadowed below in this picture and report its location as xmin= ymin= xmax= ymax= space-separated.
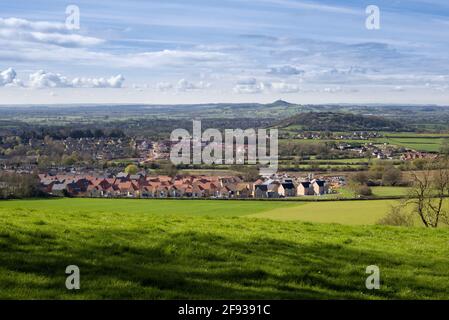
xmin=0 ymin=201 xmax=449 ymax=299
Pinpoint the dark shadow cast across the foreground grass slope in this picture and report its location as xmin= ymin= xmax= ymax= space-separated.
xmin=0 ymin=224 xmax=449 ymax=299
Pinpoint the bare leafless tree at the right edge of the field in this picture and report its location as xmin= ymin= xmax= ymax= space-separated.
xmin=405 ymin=157 xmax=449 ymax=228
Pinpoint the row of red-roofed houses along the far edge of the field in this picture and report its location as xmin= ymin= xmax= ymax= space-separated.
xmin=39 ymin=173 xmax=329 ymax=199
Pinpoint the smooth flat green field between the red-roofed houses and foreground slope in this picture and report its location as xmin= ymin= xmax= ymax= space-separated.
xmin=0 ymin=196 xmax=406 ymax=225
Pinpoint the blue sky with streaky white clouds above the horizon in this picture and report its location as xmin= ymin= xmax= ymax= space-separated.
xmin=0 ymin=0 xmax=449 ymax=105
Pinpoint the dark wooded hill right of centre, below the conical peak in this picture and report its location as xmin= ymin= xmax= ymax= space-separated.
xmin=278 ymin=112 xmax=407 ymax=131
